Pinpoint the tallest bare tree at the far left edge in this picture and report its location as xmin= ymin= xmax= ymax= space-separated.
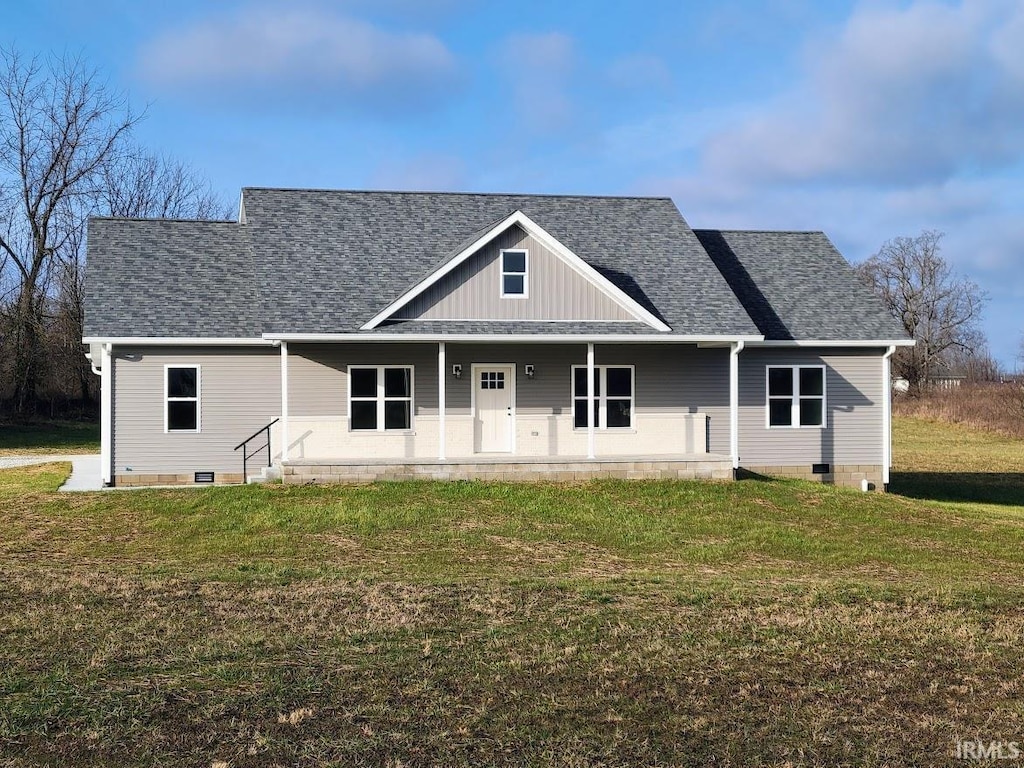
xmin=0 ymin=50 xmax=138 ymax=414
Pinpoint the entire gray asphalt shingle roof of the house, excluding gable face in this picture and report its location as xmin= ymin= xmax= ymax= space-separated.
xmin=85 ymin=188 xmax=903 ymax=340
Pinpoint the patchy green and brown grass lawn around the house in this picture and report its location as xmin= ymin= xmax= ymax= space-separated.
xmin=0 ymin=421 xmax=1024 ymax=766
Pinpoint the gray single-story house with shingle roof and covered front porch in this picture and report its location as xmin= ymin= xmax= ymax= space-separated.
xmin=84 ymin=188 xmax=912 ymax=488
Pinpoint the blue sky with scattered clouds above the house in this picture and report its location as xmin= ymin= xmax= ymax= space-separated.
xmin=8 ymin=0 xmax=1024 ymax=368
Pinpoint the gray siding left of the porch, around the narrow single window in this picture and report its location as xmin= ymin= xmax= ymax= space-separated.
xmin=113 ymin=347 xmax=281 ymax=475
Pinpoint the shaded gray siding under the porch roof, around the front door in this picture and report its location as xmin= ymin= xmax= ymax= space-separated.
xmin=288 ymin=342 xmax=729 ymax=453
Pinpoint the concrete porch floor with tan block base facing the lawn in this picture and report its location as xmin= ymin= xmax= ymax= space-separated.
xmin=282 ymin=454 xmax=732 ymax=483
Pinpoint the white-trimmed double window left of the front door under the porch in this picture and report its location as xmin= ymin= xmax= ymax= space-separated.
xmin=348 ymin=366 xmax=413 ymax=432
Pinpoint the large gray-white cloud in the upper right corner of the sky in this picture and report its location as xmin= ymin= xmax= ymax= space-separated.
xmin=705 ymin=0 xmax=1024 ymax=183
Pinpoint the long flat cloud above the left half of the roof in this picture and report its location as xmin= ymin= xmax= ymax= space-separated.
xmin=140 ymin=6 xmax=457 ymax=109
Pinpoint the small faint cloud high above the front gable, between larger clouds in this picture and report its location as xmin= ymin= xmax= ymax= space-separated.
xmin=498 ymin=32 xmax=577 ymax=133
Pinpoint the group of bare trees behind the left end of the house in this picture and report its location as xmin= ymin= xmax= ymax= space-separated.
xmin=0 ymin=49 xmax=229 ymax=417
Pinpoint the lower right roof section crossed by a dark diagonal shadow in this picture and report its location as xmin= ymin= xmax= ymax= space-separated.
xmin=694 ymin=229 xmax=906 ymax=341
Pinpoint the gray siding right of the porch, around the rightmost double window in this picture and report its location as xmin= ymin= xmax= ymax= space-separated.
xmin=739 ymin=348 xmax=884 ymax=466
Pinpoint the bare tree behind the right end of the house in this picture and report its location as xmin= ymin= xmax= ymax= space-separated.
xmin=858 ymin=230 xmax=988 ymax=393
